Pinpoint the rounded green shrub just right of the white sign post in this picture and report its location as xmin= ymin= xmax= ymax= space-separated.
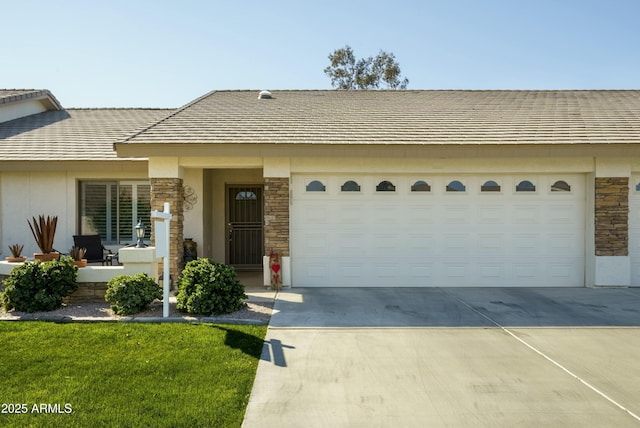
xmin=176 ymin=258 xmax=247 ymax=315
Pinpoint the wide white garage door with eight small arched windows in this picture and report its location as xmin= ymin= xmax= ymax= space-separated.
xmin=291 ymin=174 xmax=585 ymax=287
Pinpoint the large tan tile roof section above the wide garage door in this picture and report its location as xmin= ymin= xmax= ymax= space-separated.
xmin=121 ymin=90 xmax=640 ymax=144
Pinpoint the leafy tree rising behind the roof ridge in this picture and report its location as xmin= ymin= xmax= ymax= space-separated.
xmin=324 ymin=45 xmax=409 ymax=89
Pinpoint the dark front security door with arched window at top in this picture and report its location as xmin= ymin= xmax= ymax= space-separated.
xmin=227 ymin=185 xmax=263 ymax=270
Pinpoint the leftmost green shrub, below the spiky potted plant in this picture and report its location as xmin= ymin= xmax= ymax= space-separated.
xmin=0 ymin=257 xmax=78 ymax=312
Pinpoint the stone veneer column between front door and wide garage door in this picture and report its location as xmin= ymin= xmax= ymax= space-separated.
xmin=264 ymin=177 xmax=289 ymax=257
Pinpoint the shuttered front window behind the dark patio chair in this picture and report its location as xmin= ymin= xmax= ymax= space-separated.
xmin=78 ymin=181 xmax=151 ymax=245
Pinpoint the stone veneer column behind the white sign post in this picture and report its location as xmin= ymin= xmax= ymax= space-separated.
xmin=151 ymin=178 xmax=184 ymax=285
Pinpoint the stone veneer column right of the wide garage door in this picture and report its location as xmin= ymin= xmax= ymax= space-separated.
xmin=595 ymin=177 xmax=629 ymax=256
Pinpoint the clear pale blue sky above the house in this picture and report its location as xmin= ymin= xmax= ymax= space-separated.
xmin=5 ymin=0 xmax=640 ymax=107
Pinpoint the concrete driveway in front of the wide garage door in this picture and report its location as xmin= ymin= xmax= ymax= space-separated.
xmin=243 ymin=288 xmax=640 ymax=428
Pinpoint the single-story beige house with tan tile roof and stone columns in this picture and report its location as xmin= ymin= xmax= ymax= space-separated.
xmin=0 ymin=90 xmax=640 ymax=287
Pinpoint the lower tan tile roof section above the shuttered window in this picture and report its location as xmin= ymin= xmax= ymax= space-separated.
xmin=0 ymin=107 xmax=173 ymax=161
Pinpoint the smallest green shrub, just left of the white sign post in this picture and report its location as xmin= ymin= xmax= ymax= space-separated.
xmin=104 ymin=273 xmax=162 ymax=315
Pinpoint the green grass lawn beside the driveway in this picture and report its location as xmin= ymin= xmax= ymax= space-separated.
xmin=0 ymin=322 xmax=267 ymax=427
